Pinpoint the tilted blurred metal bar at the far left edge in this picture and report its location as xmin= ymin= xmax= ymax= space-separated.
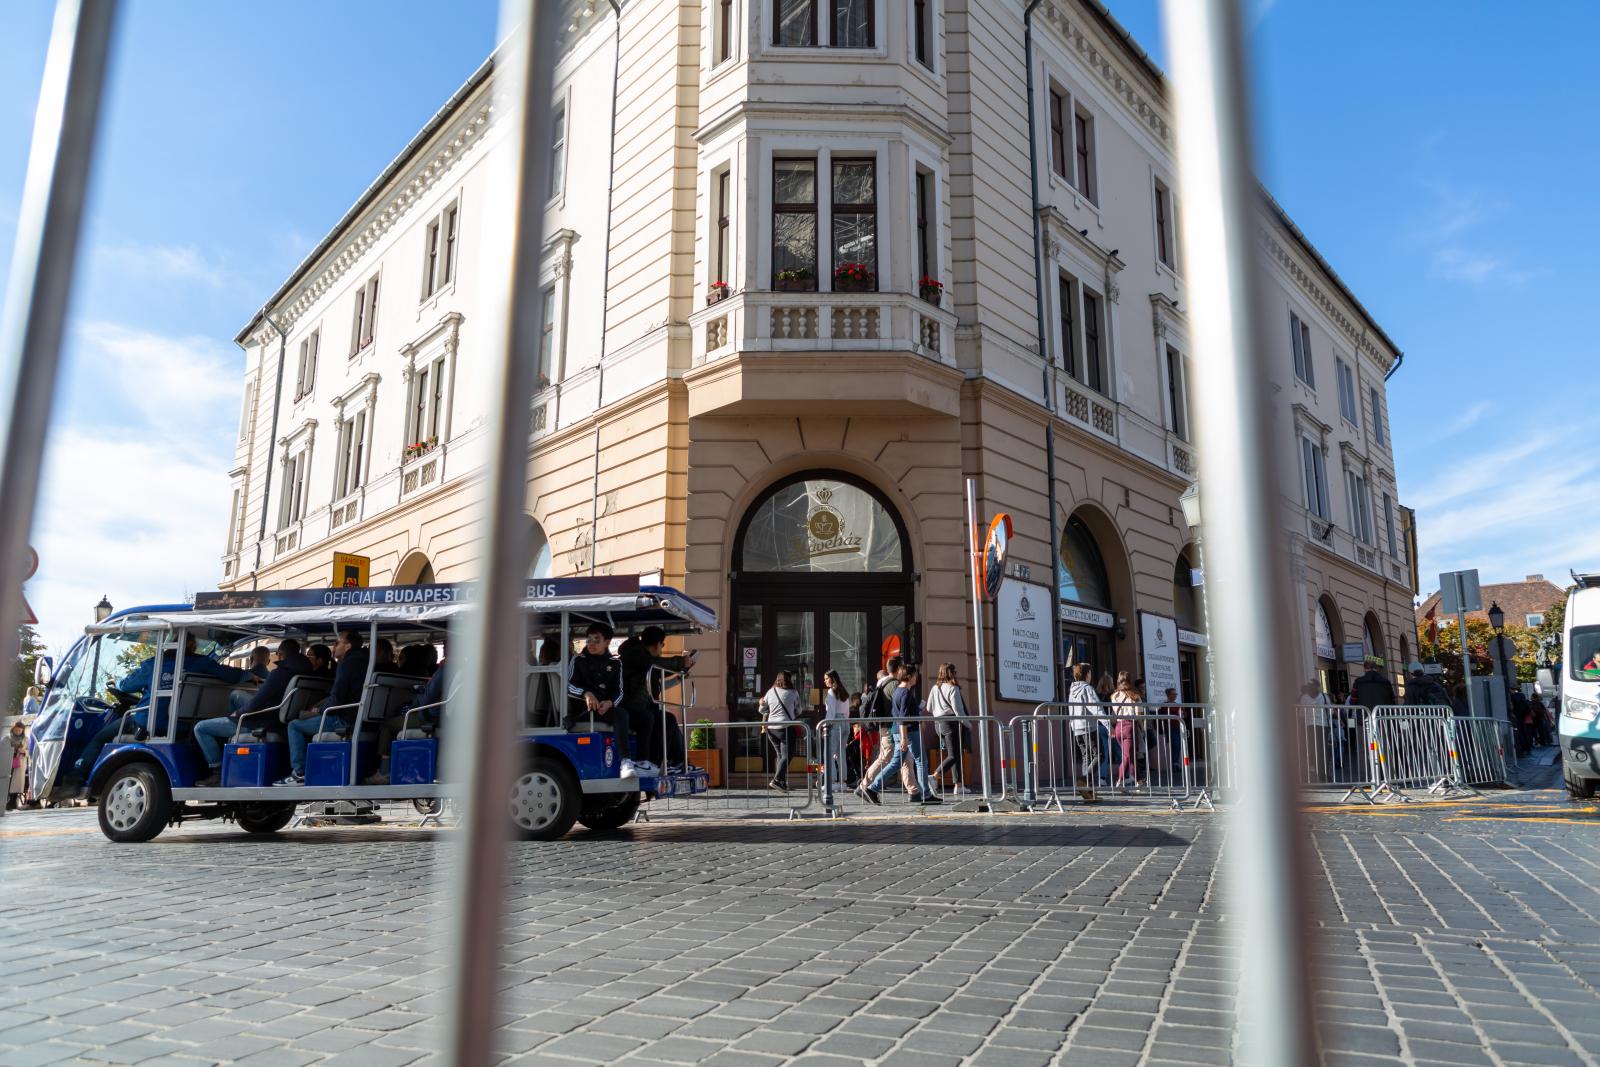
xmin=0 ymin=0 xmax=117 ymax=710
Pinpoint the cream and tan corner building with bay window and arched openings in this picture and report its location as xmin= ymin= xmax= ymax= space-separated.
xmin=222 ymin=0 xmax=1414 ymax=735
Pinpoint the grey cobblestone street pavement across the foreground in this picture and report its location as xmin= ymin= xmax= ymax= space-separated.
xmin=0 ymin=764 xmax=1600 ymax=1067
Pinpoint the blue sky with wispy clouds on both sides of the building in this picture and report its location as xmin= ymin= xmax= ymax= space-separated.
xmin=0 ymin=0 xmax=1600 ymax=646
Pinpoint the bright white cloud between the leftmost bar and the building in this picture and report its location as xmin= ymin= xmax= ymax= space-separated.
xmin=27 ymin=323 xmax=240 ymax=653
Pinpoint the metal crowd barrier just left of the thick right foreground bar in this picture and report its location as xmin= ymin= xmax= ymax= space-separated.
xmin=1005 ymin=704 xmax=1209 ymax=811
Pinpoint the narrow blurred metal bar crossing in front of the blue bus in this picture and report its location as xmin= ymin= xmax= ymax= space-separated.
xmin=445 ymin=0 xmax=565 ymax=1067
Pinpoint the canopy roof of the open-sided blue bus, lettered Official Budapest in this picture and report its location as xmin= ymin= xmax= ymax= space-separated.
xmin=85 ymin=576 xmax=717 ymax=633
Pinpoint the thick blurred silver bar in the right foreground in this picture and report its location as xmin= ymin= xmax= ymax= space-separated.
xmin=1163 ymin=0 xmax=1317 ymax=1067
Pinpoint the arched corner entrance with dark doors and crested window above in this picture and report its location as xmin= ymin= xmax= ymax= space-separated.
xmin=728 ymin=470 xmax=918 ymax=735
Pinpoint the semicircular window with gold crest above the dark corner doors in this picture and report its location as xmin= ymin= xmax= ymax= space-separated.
xmin=734 ymin=475 xmax=909 ymax=574
